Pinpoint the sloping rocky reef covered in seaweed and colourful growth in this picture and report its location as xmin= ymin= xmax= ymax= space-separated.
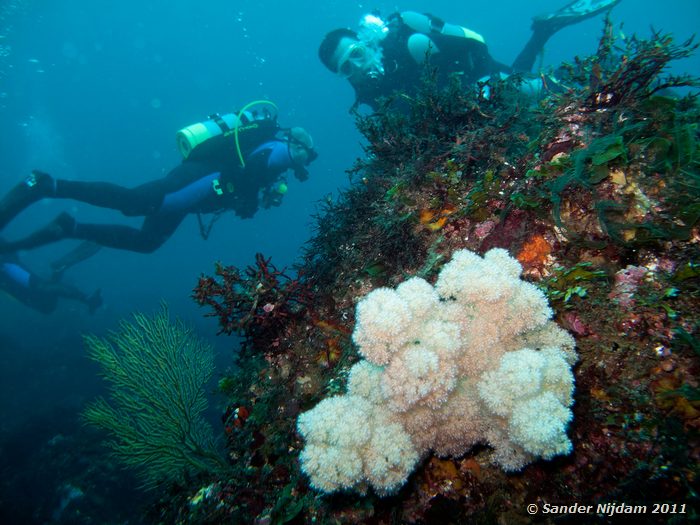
xmin=155 ymin=26 xmax=700 ymax=524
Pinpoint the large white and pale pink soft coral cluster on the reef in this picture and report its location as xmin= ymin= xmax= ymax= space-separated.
xmin=297 ymin=249 xmax=576 ymax=494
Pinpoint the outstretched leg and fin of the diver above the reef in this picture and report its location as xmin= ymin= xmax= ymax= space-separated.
xmin=512 ymin=0 xmax=621 ymax=73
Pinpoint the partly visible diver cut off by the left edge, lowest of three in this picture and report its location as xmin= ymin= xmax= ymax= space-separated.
xmin=0 ymin=245 xmax=102 ymax=314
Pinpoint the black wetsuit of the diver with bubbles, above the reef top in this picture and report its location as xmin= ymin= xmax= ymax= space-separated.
xmin=349 ymin=13 xmax=510 ymax=107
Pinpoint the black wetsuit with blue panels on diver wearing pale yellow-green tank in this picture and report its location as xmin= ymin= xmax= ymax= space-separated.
xmin=13 ymin=139 xmax=294 ymax=253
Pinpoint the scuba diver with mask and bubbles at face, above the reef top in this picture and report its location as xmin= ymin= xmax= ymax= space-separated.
xmin=318 ymin=0 xmax=620 ymax=109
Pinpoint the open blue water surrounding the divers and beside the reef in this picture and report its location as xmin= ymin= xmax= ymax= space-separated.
xmin=0 ymin=0 xmax=700 ymax=523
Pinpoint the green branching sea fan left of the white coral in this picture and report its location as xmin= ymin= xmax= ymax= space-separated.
xmin=82 ymin=307 xmax=225 ymax=488
